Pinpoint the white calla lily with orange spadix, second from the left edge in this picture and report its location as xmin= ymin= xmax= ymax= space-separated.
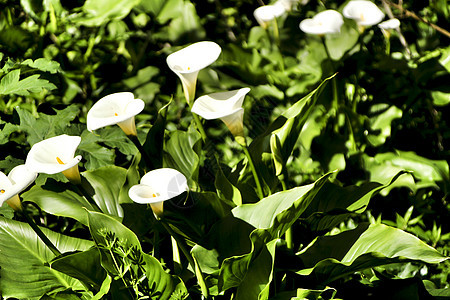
xmin=25 ymin=134 xmax=81 ymax=183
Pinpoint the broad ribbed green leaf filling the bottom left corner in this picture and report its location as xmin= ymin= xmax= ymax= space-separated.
xmin=0 ymin=217 xmax=93 ymax=299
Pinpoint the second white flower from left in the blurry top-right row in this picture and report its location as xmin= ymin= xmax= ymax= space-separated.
xmin=300 ymin=9 xmax=344 ymax=35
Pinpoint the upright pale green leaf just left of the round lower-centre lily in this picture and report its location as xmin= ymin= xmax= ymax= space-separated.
xmin=82 ymin=166 xmax=127 ymax=218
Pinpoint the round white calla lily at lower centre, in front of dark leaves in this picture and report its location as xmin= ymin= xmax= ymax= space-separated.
xmin=128 ymin=168 xmax=189 ymax=218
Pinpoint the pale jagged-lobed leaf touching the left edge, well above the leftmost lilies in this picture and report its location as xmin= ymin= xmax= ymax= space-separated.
xmin=0 ymin=69 xmax=56 ymax=96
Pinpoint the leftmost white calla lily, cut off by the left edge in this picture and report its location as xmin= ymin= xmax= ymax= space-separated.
xmin=0 ymin=165 xmax=37 ymax=211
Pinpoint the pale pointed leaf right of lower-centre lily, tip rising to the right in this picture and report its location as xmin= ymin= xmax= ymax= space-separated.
xmin=231 ymin=173 xmax=331 ymax=238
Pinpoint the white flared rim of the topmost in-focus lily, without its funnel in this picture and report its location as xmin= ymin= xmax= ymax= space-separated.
xmin=167 ymin=41 xmax=222 ymax=74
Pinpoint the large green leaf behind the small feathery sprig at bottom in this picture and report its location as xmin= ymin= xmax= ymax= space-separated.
xmin=88 ymin=212 xmax=187 ymax=299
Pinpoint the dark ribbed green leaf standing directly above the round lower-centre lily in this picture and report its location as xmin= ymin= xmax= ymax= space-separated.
xmin=164 ymin=127 xmax=201 ymax=182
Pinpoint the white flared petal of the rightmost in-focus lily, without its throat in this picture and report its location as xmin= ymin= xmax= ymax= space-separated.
xmin=192 ymin=88 xmax=250 ymax=120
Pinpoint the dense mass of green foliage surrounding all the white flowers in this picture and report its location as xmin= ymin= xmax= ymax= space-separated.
xmin=0 ymin=0 xmax=450 ymax=299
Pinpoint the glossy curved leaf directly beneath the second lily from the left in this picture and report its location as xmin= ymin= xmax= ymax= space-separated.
xmin=21 ymin=183 xmax=93 ymax=225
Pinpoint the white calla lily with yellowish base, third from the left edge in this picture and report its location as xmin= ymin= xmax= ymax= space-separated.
xmin=86 ymin=92 xmax=145 ymax=135
